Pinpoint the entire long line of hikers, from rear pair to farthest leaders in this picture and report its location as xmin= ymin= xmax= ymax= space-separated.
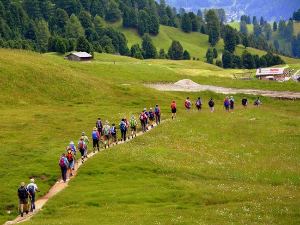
xmin=18 ymin=96 xmax=262 ymax=217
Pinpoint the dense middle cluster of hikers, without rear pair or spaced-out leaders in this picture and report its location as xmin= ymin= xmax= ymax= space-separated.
xmin=59 ymin=104 xmax=161 ymax=182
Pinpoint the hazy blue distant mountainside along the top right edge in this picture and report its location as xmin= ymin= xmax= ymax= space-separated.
xmin=166 ymin=0 xmax=300 ymax=22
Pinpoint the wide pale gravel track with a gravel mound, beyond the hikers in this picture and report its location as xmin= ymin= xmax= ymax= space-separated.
xmin=146 ymin=79 xmax=300 ymax=100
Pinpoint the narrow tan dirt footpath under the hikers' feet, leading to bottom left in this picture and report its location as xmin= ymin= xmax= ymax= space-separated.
xmin=4 ymin=120 xmax=163 ymax=225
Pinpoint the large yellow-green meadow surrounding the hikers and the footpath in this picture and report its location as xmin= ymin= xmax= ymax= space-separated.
xmin=0 ymin=49 xmax=300 ymax=224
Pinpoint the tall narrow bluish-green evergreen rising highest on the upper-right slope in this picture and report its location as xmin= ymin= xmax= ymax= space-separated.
xmin=205 ymin=9 xmax=220 ymax=46
